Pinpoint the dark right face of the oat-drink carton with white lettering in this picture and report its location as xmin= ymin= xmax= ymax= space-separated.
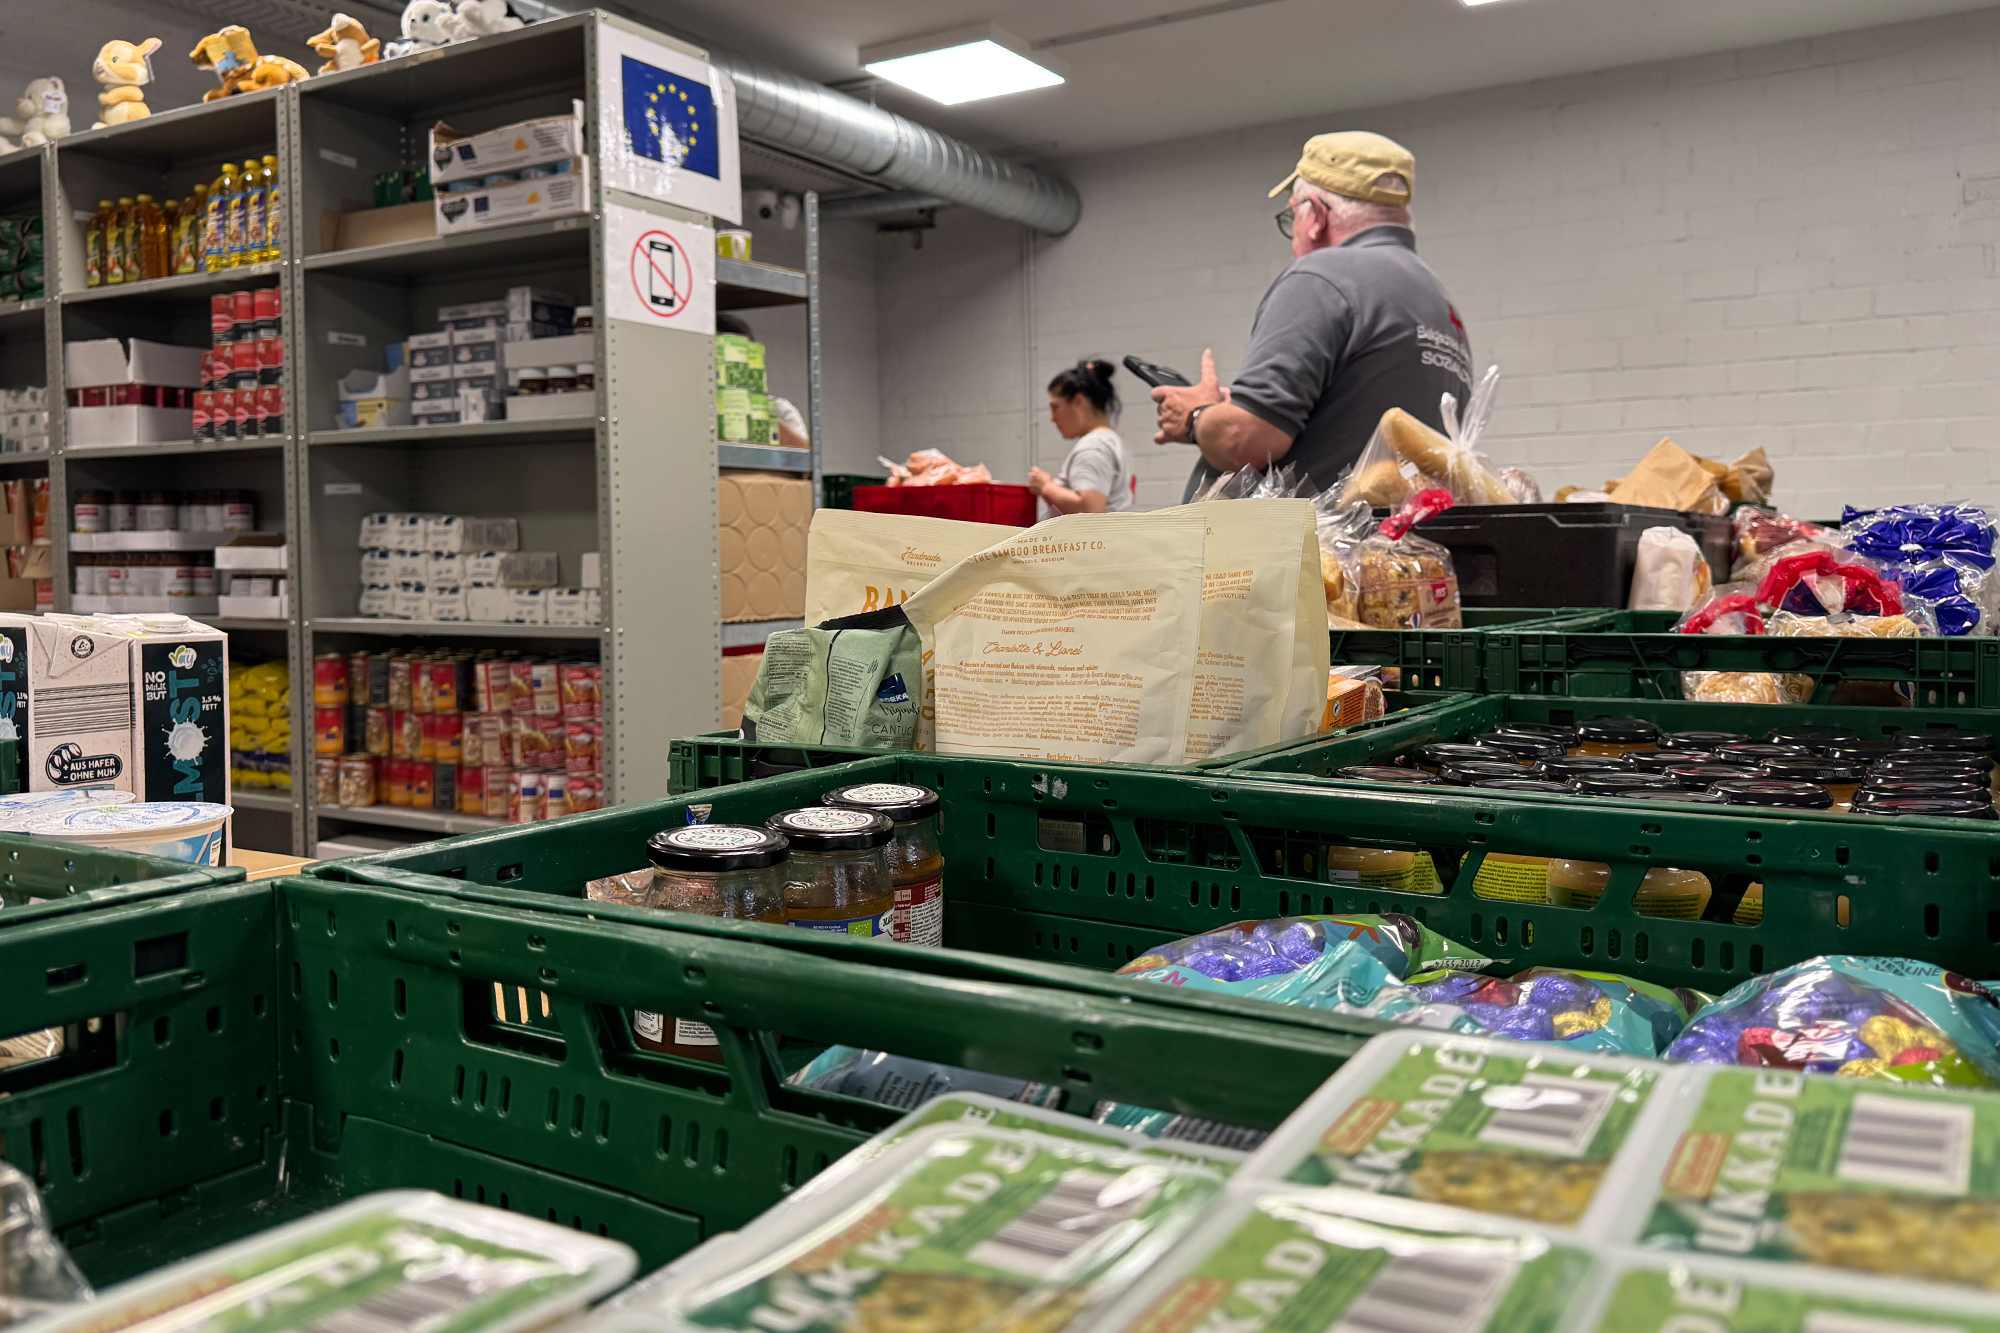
xmin=121 ymin=620 xmax=230 ymax=805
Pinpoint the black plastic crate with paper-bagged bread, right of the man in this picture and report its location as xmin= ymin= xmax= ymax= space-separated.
xmin=1412 ymin=504 xmax=1734 ymax=606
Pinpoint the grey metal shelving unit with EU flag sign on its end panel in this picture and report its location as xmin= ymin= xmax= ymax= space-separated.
xmin=25 ymin=12 xmax=820 ymax=851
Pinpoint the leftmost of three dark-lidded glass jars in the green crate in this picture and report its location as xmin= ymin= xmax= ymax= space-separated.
xmin=632 ymin=825 xmax=790 ymax=1065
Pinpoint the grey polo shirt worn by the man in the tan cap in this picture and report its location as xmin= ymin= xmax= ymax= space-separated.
xmin=1186 ymin=226 xmax=1472 ymax=500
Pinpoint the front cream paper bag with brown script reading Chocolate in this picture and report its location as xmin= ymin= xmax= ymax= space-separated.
xmin=904 ymin=506 xmax=1200 ymax=765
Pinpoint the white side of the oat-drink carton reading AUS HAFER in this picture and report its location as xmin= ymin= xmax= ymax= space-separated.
xmin=0 ymin=614 xmax=139 ymax=791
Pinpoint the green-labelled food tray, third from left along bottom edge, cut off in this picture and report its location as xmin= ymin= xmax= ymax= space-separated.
xmin=1098 ymin=1187 xmax=1600 ymax=1333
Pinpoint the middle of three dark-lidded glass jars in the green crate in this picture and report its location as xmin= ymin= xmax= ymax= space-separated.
xmin=764 ymin=805 xmax=896 ymax=937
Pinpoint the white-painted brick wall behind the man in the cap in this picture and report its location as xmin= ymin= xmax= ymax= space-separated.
xmin=876 ymin=10 xmax=2000 ymax=516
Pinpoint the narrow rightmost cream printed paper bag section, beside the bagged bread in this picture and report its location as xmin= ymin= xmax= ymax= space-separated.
xmin=1186 ymin=500 xmax=1328 ymax=763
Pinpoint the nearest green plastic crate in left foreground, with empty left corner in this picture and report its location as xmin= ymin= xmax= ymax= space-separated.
xmin=0 ymin=877 xmax=1380 ymax=1283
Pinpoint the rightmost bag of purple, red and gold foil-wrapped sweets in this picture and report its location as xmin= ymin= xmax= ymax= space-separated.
xmin=1666 ymin=955 xmax=2000 ymax=1089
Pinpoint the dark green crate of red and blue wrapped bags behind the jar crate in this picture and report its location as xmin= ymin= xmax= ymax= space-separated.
xmin=1484 ymin=610 xmax=2000 ymax=709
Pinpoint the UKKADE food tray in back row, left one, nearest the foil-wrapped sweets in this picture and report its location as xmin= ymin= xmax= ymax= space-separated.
xmin=1238 ymin=1033 xmax=1700 ymax=1224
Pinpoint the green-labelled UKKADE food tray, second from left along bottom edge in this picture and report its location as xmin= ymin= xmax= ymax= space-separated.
xmin=622 ymin=1125 xmax=1224 ymax=1333
